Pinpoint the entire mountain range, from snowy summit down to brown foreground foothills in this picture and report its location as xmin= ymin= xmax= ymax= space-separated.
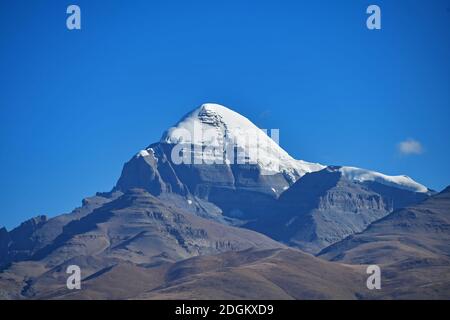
xmin=0 ymin=104 xmax=450 ymax=299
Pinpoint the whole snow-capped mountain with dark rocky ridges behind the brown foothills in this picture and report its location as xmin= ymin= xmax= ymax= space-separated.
xmin=0 ymin=104 xmax=431 ymax=266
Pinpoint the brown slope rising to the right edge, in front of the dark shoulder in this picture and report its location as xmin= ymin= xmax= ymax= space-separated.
xmin=320 ymin=187 xmax=450 ymax=263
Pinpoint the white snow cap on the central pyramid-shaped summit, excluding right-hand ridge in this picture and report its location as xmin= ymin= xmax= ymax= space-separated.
xmin=161 ymin=103 xmax=324 ymax=182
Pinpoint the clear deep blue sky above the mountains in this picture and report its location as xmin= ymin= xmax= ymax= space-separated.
xmin=0 ymin=0 xmax=450 ymax=228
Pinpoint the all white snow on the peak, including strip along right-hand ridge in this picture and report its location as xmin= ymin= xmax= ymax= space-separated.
xmin=156 ymin=103 xmax=429 ymax=193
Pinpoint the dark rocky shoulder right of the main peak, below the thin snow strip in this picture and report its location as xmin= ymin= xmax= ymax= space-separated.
xmin=246 ymin=167 xmax=428 ymax=253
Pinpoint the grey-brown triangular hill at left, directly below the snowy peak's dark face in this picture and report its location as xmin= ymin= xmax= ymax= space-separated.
xmin=0 ymin=189 xmax=284 ymax=298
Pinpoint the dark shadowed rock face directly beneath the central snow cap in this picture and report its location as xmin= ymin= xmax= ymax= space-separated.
xmin=115 ymin=143 xmax=292 ymax=220
